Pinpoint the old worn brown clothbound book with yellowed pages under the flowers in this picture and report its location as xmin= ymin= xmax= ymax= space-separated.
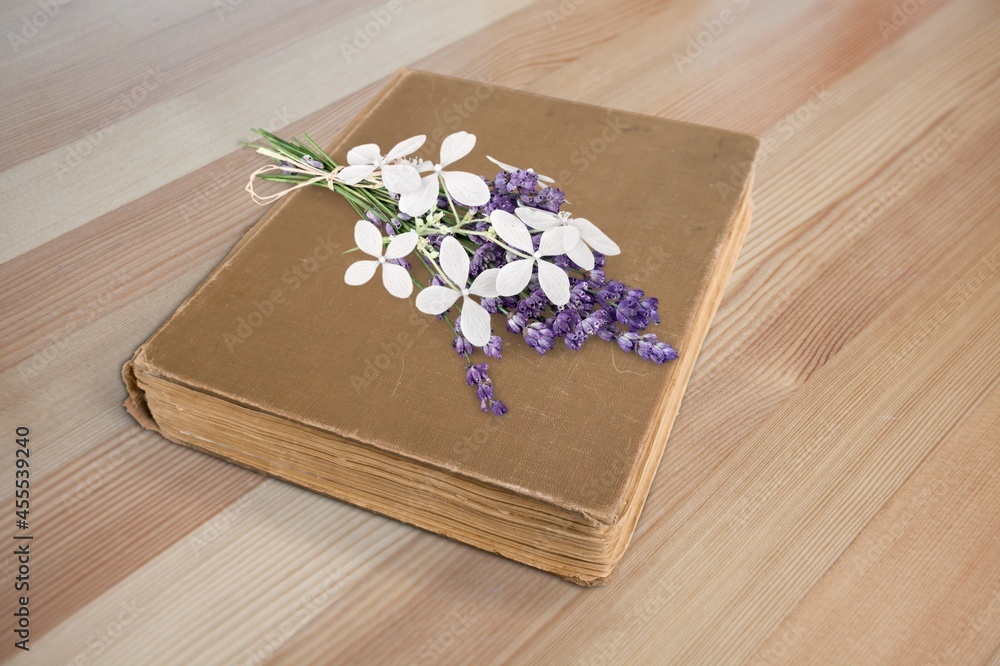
xmin=123 ymin=70 xmax=759 ymax=585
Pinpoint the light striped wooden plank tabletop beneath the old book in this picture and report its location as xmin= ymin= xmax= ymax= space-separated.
xmin=0 ymin=0 xmax=1000 ymax=664
